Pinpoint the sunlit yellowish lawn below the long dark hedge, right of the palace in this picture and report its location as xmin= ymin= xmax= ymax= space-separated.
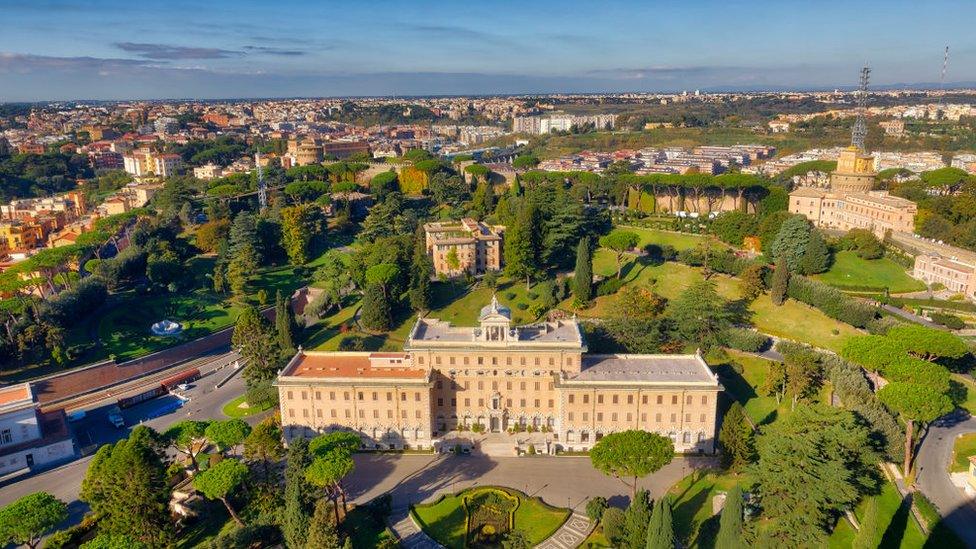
xmin=749 ymin=295 xmax=861 ymax=352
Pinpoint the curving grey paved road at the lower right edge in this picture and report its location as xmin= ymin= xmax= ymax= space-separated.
xmin=916 ymin=417 xmax=976 ymax=547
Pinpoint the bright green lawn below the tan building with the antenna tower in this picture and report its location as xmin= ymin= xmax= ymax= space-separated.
xmin=814 ymin=251 xmax=925 ymax=293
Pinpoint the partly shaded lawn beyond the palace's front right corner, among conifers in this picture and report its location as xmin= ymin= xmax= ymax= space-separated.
xmin=668 ymin=471 xmax=752 ymax=547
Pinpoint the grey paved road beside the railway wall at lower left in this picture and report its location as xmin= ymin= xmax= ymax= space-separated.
xmin=0 ymin=358 xmax=261 ymax=526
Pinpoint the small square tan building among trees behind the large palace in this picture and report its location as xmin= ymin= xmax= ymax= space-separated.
xmin=424 ymin=218 xmax=505 ymax=276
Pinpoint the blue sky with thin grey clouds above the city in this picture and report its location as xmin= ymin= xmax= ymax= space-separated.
xmin=0 ymin=0 xmax=976 ymax=102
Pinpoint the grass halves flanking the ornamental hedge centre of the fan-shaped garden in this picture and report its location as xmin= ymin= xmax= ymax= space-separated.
xmin=411 ymin=487 xmax=570 ymax=549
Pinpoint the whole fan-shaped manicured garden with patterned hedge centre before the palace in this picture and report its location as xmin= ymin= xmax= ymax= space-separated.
xmin=410 ymin=487 xmax=570 ymax=548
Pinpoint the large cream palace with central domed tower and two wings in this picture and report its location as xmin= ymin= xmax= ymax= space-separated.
xmin=276 ymin=298 xmax=722 ymax=452
